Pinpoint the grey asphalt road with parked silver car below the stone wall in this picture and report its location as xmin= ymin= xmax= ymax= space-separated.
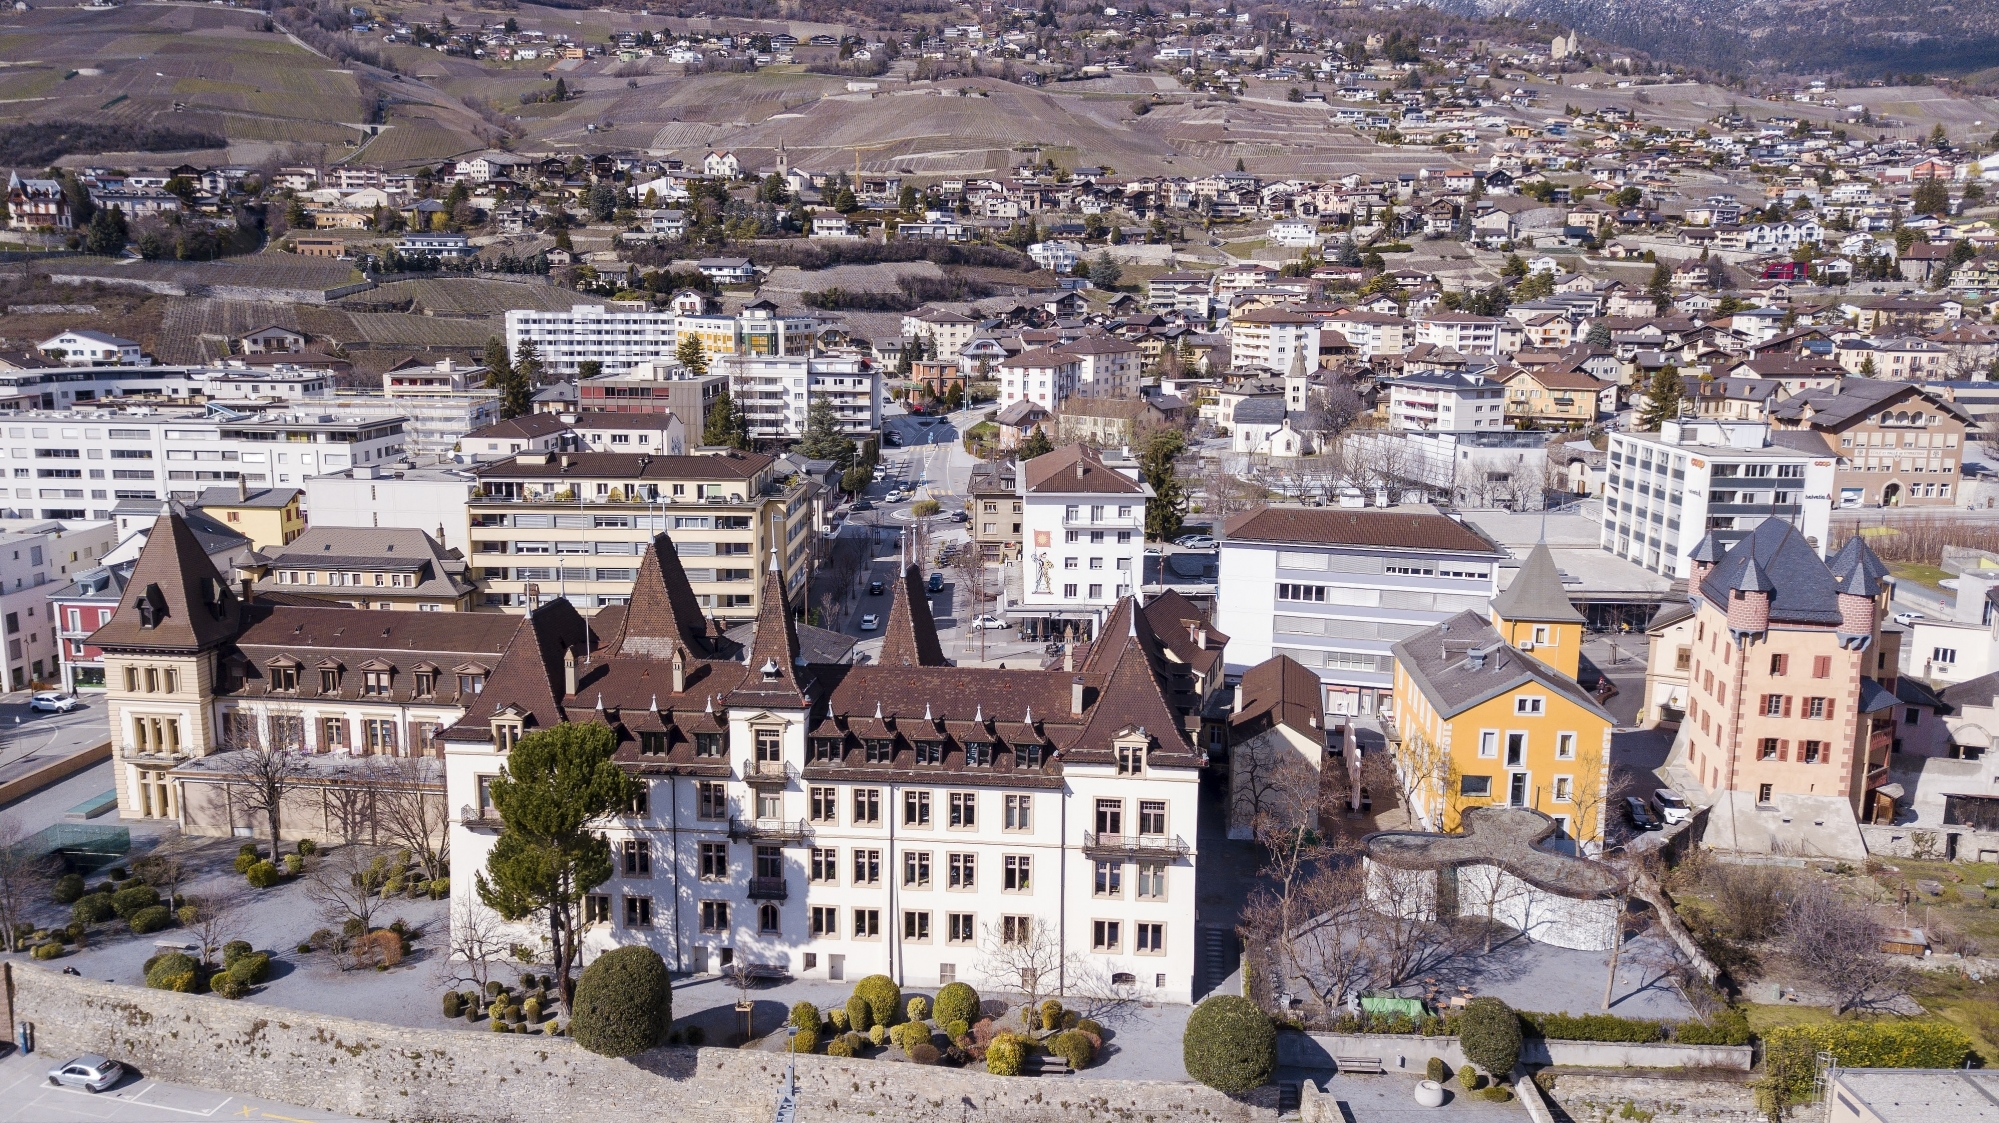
xmin=0 ymin=1047 xmax=364 ymax=1123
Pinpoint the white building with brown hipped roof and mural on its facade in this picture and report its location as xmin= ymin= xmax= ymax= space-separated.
xmin=1007 ymin=444 xmax=1153 ymax=639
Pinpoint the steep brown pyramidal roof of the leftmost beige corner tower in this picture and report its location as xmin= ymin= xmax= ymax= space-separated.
xmin=90 ymin=510 xmax=242 ymax=651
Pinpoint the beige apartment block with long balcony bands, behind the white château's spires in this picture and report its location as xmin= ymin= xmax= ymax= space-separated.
xmin=466 ymin=450 xmax=812 ymax=623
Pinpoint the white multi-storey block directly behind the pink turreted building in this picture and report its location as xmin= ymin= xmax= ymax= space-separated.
xmin=1603 ymin=418 xmax=1833 ymax=577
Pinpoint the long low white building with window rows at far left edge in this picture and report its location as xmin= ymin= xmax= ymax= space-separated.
xmin=0 ymin=410 xmax=404 ymax=520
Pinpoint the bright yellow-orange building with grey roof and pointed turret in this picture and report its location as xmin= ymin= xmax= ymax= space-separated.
xmin=1389 ymin=546 xmax=1613 ymax=847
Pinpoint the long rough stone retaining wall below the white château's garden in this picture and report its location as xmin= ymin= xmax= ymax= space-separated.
xmin=4 ymin=963 xmax=1277 ymax=1123
